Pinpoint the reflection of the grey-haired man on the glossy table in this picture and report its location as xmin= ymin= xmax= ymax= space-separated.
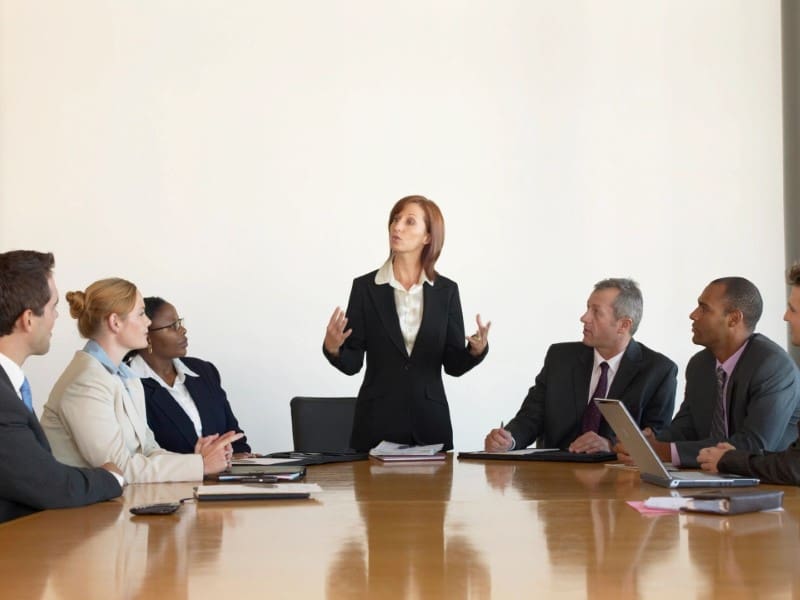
xmin=484 ymin=462 xmax=680 ymax=599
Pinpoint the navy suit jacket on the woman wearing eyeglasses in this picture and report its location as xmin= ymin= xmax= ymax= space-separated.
xmin=142 ymin=356 xmax=250 ymax=454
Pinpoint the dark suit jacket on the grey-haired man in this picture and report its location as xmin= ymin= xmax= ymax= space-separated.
xmin=505 ymin=340 xmax=678 ymax=448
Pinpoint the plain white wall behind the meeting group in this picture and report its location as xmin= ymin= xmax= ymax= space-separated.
xmin=0 ymin=0 xmax=785 ymax=451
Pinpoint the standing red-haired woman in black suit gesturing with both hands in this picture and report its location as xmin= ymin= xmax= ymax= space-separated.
xmin=322 ymin=196 xmax=491 ymax=452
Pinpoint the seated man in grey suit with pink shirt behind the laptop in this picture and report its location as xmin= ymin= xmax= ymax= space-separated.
xmin=632 ymin=277 xmax=800 ymax=467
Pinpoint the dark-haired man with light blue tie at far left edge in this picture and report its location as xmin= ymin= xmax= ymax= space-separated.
xmin=0 ymin=250 xmax=124 ymax=522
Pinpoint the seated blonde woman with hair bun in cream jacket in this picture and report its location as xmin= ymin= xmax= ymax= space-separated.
xmin=41 ymin=278 xmax=242 ymax=483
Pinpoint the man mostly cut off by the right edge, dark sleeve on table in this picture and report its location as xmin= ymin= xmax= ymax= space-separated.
xmin=697 ymin=263 xmax=800 ymax=485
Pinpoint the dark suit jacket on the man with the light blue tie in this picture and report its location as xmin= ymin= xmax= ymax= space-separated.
xmin=0 ymin=367 xmax=122 ymax=522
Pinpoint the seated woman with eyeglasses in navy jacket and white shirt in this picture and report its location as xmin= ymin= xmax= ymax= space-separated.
xmin=128 ymin=297 xmax=256 ymax=458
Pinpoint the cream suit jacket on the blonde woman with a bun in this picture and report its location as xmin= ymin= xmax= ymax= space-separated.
xmin=42 ymin=351 xmax=203 ymax=483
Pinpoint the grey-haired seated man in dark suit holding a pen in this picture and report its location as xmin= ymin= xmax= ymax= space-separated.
xmin=484 ymin=279 xmax=678 ymax=452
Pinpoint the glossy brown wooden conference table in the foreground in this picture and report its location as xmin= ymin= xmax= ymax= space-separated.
xmin=0 ymin=456 xmax=800 ymax=600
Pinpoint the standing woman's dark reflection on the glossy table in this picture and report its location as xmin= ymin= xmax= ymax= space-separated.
xmin=327 ymin=458 xmax=491 ymax=599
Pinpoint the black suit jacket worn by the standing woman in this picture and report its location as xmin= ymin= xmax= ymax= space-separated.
xmin=323 ymin=271 xmax=489 ymax=452
